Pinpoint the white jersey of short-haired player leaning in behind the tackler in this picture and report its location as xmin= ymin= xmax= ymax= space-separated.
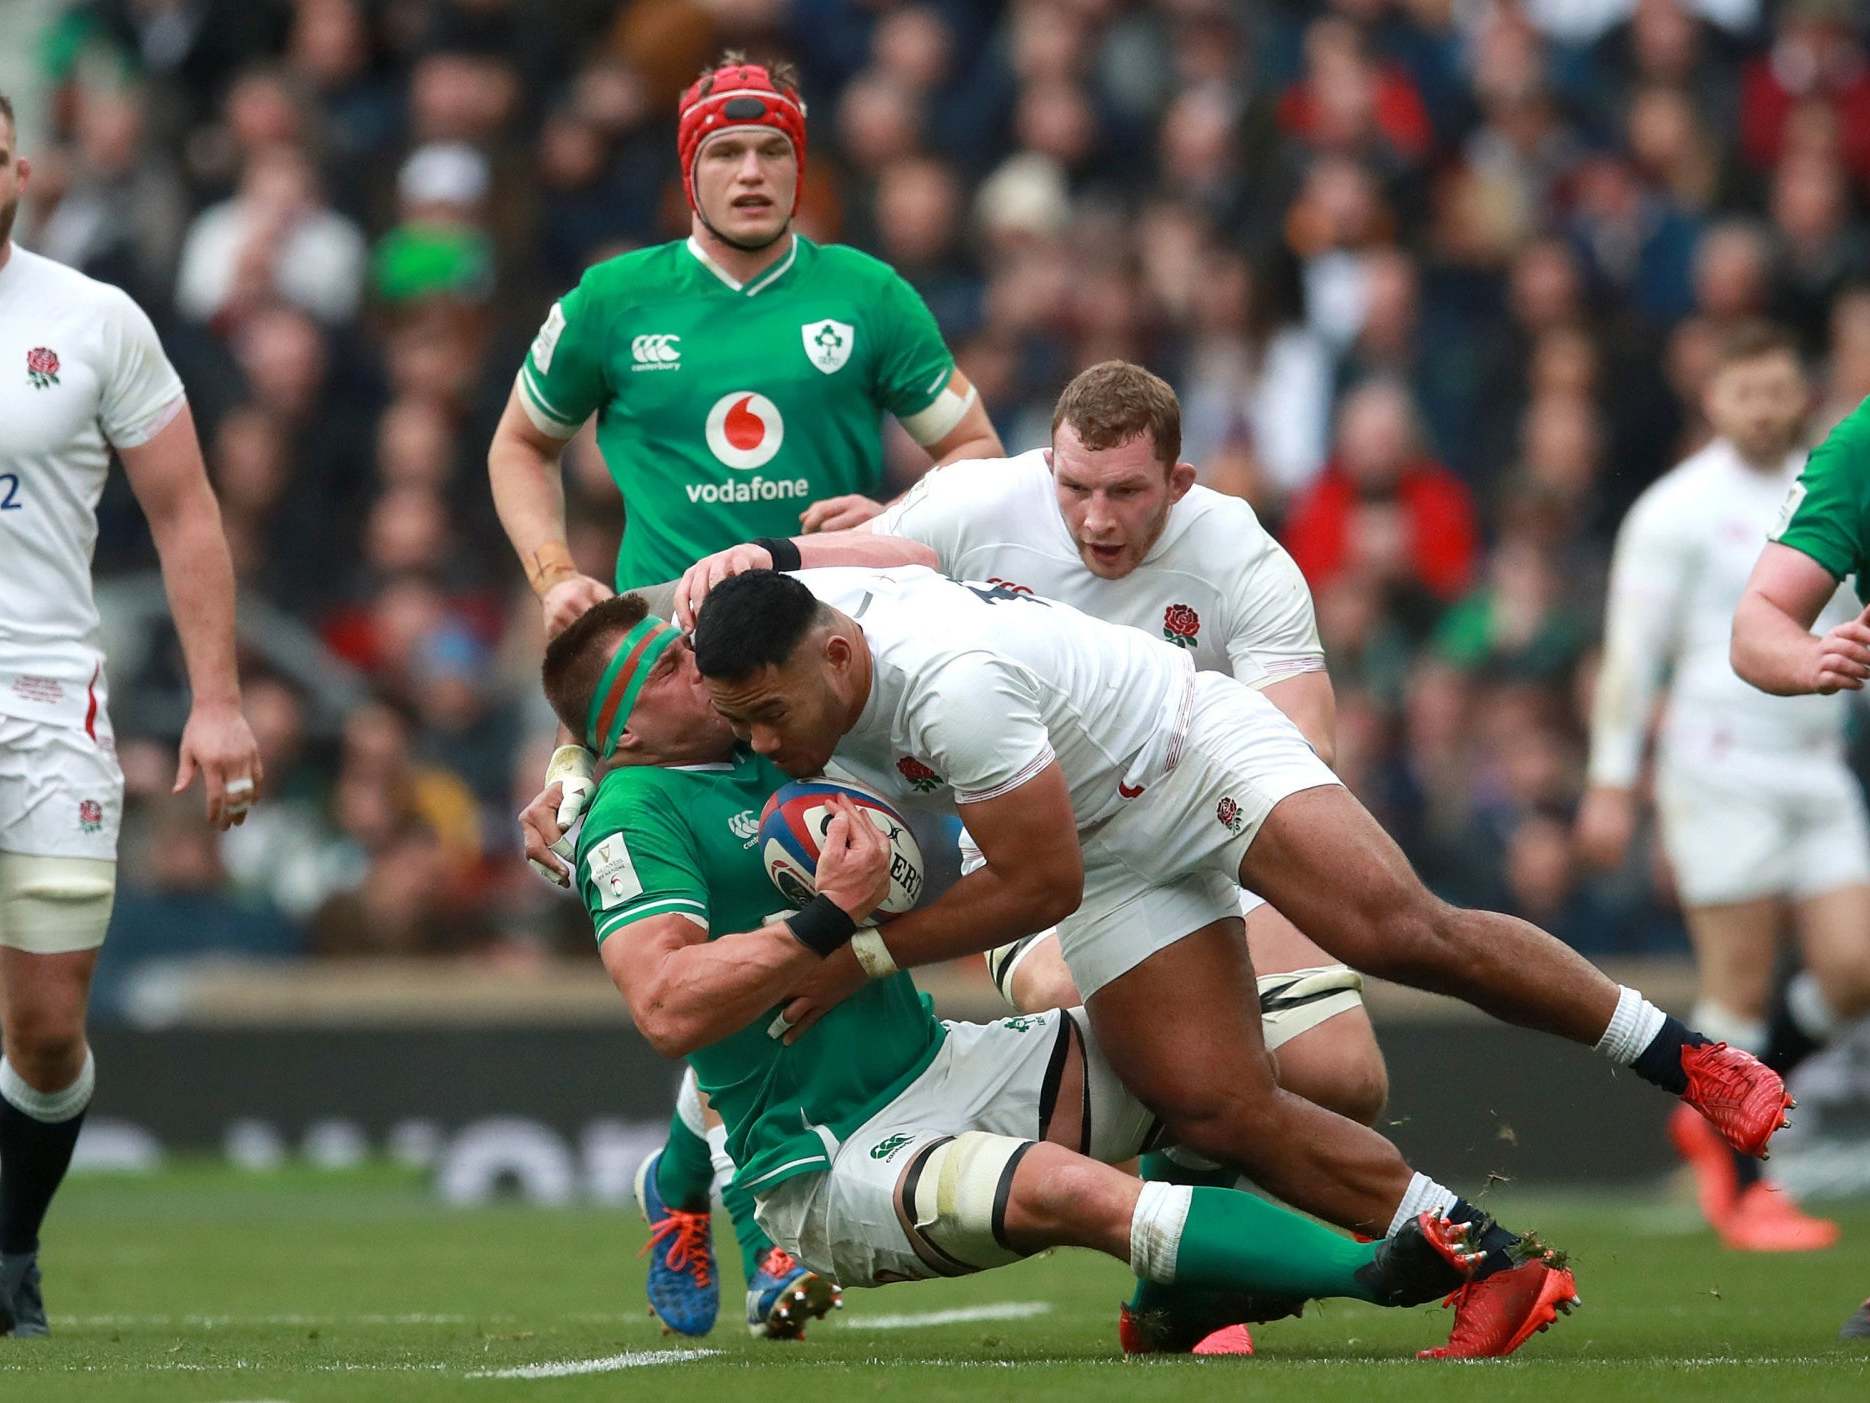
xmin=871 ymin=449 xmax=1324 ymax=687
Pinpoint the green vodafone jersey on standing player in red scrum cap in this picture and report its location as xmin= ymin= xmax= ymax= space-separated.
xmin=520 ymin=236 xmax=954 ymax=589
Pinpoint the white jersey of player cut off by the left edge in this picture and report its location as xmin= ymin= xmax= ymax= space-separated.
xmin=0 ymin=245 xmax=183 ymax=726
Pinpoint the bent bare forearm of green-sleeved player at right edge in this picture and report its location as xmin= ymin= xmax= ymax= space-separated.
xmin=1728 ymin=542 xmax=1870 ymax=696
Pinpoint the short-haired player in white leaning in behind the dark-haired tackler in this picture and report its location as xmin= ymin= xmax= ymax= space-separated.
xmin=675 ymin=361 xmax=1388 ymax=1352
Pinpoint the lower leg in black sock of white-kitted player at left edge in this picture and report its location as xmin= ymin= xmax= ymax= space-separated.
xmin=0 ymin=946 xmax=97 ymax=1336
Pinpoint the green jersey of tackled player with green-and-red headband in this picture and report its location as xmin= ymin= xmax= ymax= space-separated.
xmin=578 ymin=746 xmax=946 ymax=1192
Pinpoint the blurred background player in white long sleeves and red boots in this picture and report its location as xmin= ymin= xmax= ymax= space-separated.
xmin=1578 ymin=324 xmax=1870 ymax=1251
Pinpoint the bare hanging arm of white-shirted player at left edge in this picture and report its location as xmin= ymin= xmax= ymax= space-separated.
xmin=118 ymin=404 xmax=262 ymax=829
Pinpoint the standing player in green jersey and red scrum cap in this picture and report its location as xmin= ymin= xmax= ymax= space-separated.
xmin=488 ymin=54 xmax=1002 ymax=1334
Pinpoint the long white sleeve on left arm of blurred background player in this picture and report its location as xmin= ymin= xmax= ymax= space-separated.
xmin=1590 ymin=479 xmax=1700 ymax=788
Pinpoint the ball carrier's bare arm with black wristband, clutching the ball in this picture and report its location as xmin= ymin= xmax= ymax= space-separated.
xmin=602 ymin=795 xmax=890 ymax=1057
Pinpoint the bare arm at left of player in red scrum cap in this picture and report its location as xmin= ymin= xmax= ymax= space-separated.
xmin=486 ymin=387 xmax=613 ymax=636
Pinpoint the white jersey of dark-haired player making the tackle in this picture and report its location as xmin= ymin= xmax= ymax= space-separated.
xmin=798 ymin=565 xmax=1195 ymax=829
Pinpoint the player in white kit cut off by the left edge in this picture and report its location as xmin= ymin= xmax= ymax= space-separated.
xmin=0 ymin=97 xmax=260 ymax=1336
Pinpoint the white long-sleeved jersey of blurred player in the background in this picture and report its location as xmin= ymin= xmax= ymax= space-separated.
xmin=1590 ymin=440 xmax=1857 ymax=788
